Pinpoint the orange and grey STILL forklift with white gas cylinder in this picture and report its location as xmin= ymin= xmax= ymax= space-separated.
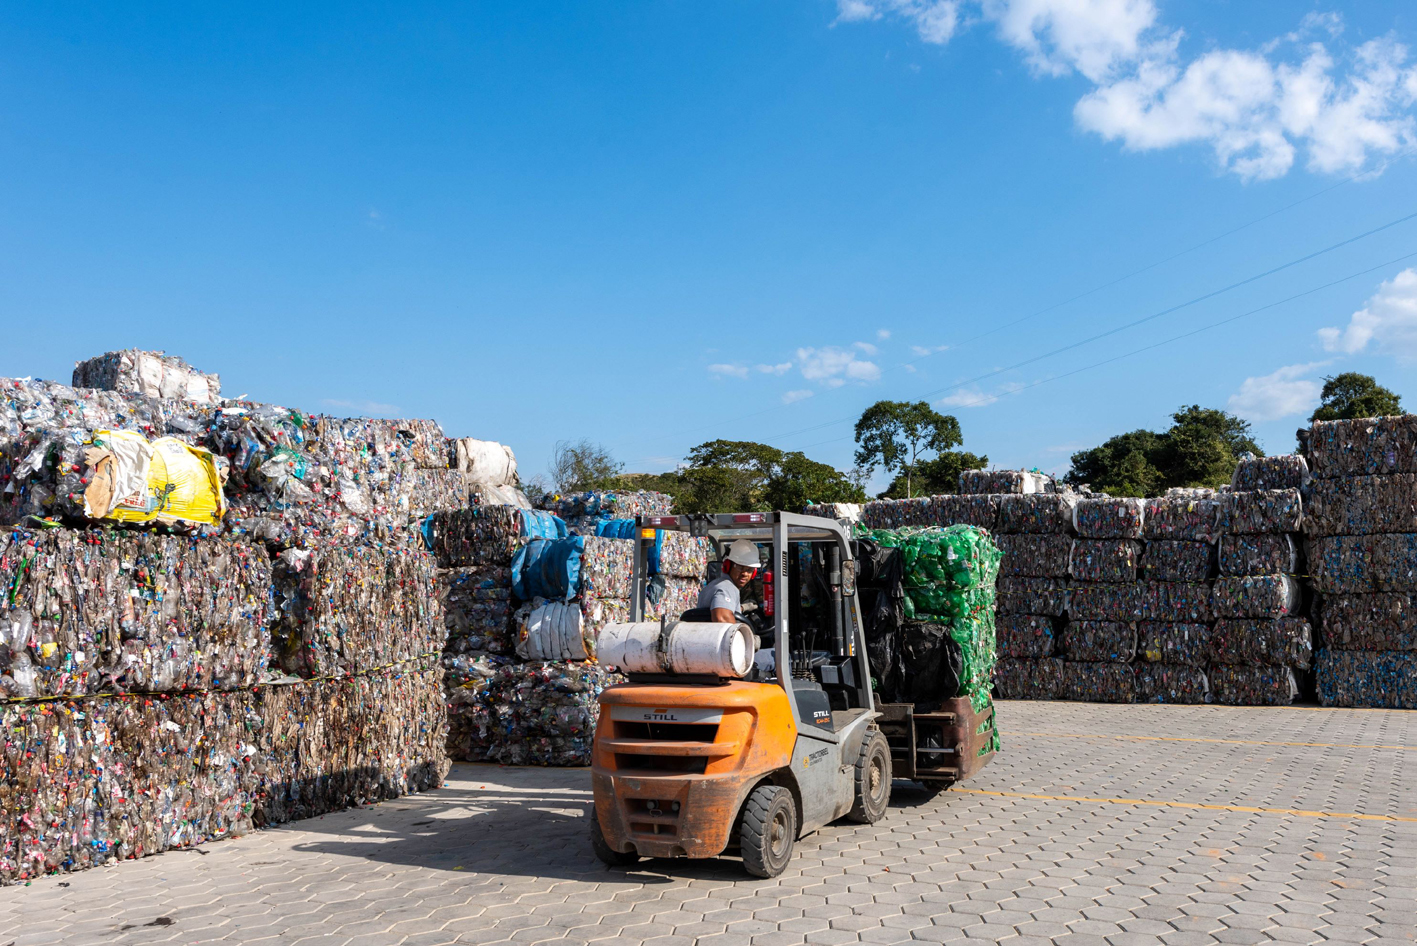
xmin=591 ymin=513 xmax=897 ymax=877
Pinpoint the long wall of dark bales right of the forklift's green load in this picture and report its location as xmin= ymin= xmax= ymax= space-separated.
xmin=862 ymin=457 xmax=1314 ymax=704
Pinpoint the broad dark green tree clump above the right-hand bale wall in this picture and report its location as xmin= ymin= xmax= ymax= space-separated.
xmin=1063 ymin=405 xmax=1264 ymax=496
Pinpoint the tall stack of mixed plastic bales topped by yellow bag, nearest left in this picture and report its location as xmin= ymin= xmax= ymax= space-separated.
xmin=0 ymin=351 xmax=461 ymax=881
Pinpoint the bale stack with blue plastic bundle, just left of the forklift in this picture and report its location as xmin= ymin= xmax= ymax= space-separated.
xmin=425 ymin=497 xmax=709 ymax=765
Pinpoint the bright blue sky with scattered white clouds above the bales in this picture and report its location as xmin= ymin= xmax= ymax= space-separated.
xmin=0 ymin=0 xmax=1417 ymax=495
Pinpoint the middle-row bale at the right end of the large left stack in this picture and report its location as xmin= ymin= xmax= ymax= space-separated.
xmin=272 ymin=542 xmax=448 ymax=677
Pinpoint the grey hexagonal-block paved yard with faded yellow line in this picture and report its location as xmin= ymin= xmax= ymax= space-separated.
xmin=0 ymin=702 xmax=1417 ymax=946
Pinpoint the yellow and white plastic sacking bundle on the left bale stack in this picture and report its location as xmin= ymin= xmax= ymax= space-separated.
xmin=84 ymin=431 xmax=227 ymax=525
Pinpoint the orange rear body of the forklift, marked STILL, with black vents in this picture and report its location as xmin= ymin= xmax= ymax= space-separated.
xmin=591 ymin=681 xmax=796 ymax=857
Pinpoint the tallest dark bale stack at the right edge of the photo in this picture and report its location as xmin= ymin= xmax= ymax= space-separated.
xmin=1304 ymin=415 xmax=1417 ymax=708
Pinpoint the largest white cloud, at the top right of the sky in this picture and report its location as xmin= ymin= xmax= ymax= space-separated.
xmin=839 ymin=0 xmax=1417 ymax=180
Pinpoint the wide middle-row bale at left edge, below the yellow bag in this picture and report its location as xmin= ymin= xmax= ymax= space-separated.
xmin=0 ymin=528 xmax=271 ymax=700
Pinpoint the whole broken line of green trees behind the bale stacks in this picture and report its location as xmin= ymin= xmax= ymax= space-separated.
xmin=531 ymin=372 xmax=1403 ymax=513
